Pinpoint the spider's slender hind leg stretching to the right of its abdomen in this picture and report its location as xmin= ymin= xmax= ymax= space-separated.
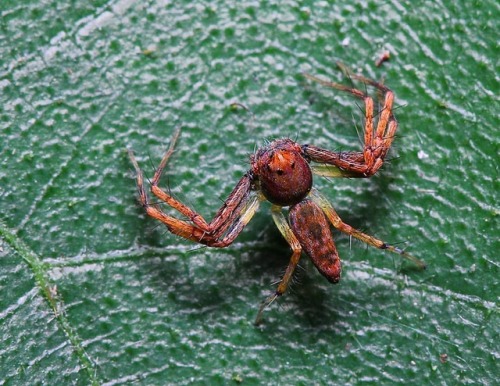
xmin=310 ymin=189 xmax=426 ymax=269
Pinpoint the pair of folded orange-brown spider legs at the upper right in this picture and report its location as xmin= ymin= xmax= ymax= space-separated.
xmin=303 ymin=74 xmax=398 ymax=177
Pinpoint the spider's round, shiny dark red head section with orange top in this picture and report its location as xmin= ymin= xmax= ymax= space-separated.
xmin=251 ymin=139 xmax=312 ymax=206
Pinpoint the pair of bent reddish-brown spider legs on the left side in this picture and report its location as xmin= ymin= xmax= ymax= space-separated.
xmin=129 ymin=129 xmax=260 ymax=248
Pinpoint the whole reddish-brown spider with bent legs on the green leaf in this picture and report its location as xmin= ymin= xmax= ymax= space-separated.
xmin=129 ymin=74 xmax=425 ymax=324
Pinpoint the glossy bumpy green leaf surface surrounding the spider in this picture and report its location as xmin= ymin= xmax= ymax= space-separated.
xmin=0 ymin=0 xmax=500 ymax=385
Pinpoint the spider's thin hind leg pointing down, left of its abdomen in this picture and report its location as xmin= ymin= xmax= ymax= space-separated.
xmin=255 ymin=205 xmax=302 ymax=325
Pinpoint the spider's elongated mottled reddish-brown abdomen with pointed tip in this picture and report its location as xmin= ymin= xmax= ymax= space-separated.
xmin=289 ymin=199 xmax=342 ymax=283
